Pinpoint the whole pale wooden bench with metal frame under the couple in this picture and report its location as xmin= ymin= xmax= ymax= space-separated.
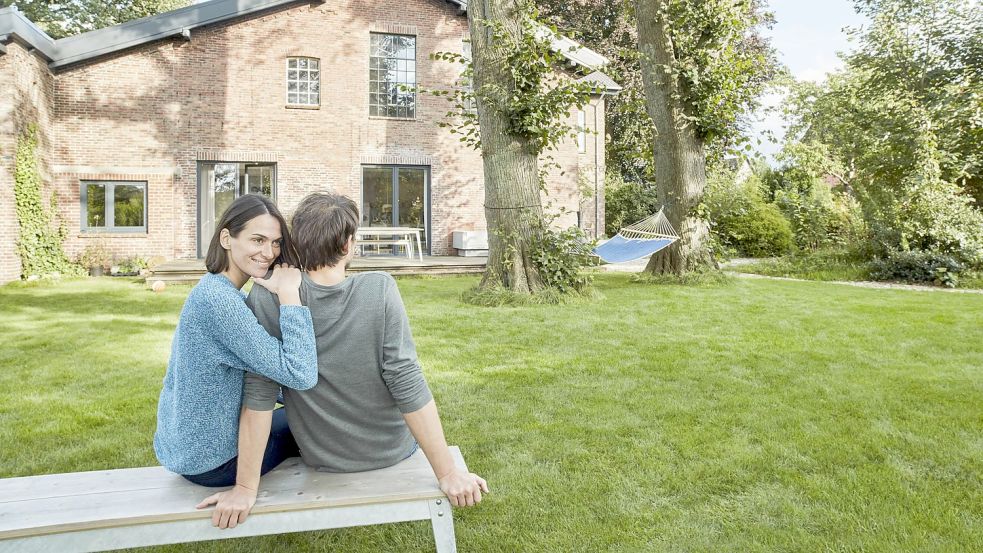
xmin=0 ymin=447 xmax=466 ymax=553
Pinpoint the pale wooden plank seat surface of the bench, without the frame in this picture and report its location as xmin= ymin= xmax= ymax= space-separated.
xmin=0 ymin=446 xmax=467 ymax=544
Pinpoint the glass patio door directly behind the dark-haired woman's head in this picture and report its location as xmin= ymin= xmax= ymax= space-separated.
xmin=198 ymin=162 xmax=276 ymax=257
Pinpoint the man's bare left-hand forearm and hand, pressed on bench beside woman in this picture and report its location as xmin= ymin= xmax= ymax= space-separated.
xmin=197 ymin=407 xmax=273 ymax=529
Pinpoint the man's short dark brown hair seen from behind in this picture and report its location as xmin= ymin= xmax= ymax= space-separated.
xmin=291 ymin=192 xmax=358 ymax=271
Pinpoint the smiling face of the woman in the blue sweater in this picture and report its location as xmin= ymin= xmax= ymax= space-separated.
xmin=221 ymin=214 xmax=283 ymax=288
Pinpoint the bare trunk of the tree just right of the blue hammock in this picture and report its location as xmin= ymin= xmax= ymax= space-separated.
xmin=636 ymin=0 xmax=715 ymax=275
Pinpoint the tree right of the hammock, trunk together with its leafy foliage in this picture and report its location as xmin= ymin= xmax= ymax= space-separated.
xmin=635 ymin=0 xmax=777 ymax=274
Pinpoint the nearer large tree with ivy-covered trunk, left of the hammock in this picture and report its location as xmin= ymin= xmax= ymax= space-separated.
xmin=468 ymin=0 xmax=591 ymax=294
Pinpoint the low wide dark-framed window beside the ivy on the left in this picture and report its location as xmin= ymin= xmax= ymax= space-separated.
xmin=79 ymin=181 xmax=147 ymax=232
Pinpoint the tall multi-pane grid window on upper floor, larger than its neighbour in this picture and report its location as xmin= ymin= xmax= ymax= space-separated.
xmin=369 ymin=33 xmax=416 ymax=119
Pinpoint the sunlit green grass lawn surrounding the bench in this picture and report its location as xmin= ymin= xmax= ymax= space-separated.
xmin=0 ymin=275 xmax=983 ymax=553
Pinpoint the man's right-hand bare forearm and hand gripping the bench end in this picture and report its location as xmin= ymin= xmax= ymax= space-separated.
xmin=403 ymin=400 xmax=488 ymax=507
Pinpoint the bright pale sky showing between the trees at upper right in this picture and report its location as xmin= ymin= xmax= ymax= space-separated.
xmin=752 ymin=0 xmax=864 ymax=160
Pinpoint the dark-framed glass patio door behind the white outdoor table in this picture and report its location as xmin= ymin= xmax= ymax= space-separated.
xmin=362 ymin=165 xmax=430 ymax=253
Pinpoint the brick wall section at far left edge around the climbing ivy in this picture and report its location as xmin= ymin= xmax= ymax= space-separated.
xmin=0 ymin=43 xmax=55 ymax=283
